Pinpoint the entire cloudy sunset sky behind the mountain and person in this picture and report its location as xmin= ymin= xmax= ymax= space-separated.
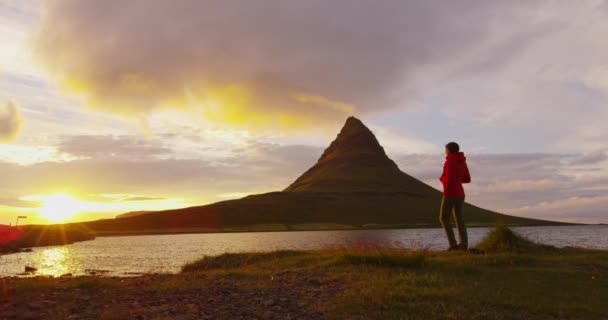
xmin=0 ymin=0 xmax=608 ymax=224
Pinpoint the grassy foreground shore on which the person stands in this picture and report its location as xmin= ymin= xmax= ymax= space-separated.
xmin=0 ymin=228 xmax=608 ymax=319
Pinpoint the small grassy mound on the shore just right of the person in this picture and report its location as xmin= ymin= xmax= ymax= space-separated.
xmin=476 ymin=225 xmax=557 ymax=253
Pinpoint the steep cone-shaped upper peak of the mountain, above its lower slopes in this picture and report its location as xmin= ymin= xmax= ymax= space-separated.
xmin=285 ymin=117 xmax=437 ymax=195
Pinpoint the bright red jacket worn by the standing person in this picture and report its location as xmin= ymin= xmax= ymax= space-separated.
xmin=439 ymin=152 xmax=471 ymax=198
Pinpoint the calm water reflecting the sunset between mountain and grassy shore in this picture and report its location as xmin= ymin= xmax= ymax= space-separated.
xmin=0 ymin=226 xmax=608 ymax=276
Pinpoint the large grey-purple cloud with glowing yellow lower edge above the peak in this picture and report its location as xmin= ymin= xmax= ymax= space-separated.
xmin=35 ymin=0 xmax=536 ymax=127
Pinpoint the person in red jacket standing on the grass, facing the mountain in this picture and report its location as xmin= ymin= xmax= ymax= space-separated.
xmin=439 ymin=142 xmax=471 ymax=250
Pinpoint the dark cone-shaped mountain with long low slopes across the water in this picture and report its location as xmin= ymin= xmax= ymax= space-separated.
xmin=78 ymin=117 xmax=564 ymax=234
